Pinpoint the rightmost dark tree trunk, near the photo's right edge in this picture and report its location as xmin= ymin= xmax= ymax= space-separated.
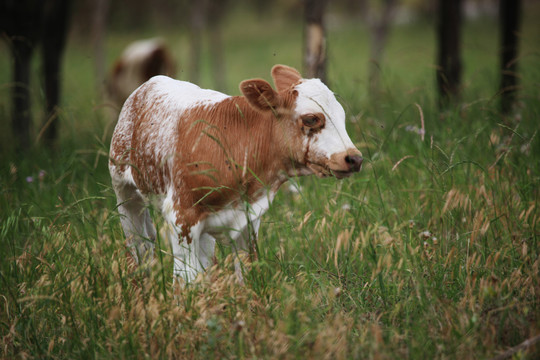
xmin=499 ymin=0 xmax=521 ymax=114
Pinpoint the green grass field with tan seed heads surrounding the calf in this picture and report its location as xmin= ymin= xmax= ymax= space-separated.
xmin=0 ymin=6 xmax=540 ymax=359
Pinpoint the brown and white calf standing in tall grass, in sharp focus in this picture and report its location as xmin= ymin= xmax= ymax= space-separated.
xmin=109 ymin=65 xmax=362 ymax=281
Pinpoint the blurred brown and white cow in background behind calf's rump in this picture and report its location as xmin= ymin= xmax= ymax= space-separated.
xmin=107 ymin=38 xmax=176 ymax=109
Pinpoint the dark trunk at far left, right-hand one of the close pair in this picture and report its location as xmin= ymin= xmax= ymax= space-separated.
xmin=42 ymin=0 xmax=71 ymax=146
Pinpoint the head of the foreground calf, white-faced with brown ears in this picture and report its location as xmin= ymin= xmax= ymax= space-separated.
xmin=240 ymin=65 xmax=363 ymax=178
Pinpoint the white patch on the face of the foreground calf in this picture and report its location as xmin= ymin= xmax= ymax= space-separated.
xmin=295 ymin=79 xmax=355 ymax=163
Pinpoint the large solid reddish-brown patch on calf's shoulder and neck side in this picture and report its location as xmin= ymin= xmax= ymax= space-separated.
xmin=172 ymin=97 xmax=280 ymax=210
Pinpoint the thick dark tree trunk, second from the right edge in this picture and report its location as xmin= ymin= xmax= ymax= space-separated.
xmin=437 ymin=0 xmax=461 ymax=108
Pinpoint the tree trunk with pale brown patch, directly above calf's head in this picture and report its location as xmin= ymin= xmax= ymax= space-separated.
xmin=304 ymin=0 xmax=328 ymax=82
